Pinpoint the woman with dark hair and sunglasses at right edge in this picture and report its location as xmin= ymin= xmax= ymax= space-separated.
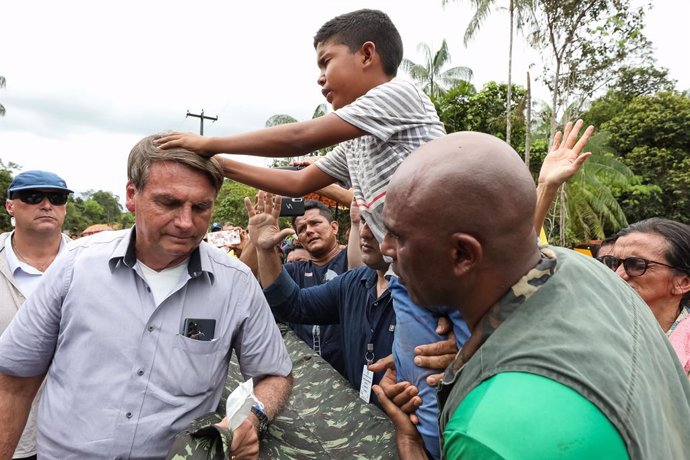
xmin=599 ymin=217 xmax=690 ymax=376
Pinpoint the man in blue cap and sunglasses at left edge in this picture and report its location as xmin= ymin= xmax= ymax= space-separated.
xmin=0 ymin=171 xmax=72 ymax=459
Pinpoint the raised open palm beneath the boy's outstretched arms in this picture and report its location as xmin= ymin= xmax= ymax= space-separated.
xmin=244 ymin=192 xmax=295 ymax=251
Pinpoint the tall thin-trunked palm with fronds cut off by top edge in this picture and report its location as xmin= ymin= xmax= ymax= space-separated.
xmin=442 ymin=0 xmax=534 ymax=144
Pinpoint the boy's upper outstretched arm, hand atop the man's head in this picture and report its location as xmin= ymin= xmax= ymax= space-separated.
xmin=157 ymin=113 xmax=366 ymax=157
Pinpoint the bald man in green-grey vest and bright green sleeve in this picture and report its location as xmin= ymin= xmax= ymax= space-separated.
xmin=374 ymin=132 xmax=690 ymax=459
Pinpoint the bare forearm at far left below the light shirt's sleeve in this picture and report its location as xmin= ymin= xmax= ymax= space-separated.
xmin=0 ymin=374 xmax=44 ymax=459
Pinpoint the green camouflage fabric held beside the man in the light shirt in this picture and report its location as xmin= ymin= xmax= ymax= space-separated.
xmin=168 ymin=328 xmax=397 ymax=460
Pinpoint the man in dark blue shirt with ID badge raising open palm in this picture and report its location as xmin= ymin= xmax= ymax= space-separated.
xmin=247 ymin=192 xmax=457 ymax=414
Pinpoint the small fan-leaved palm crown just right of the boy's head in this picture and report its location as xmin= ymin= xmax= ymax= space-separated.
xmin=402 ymin=40 xmax=472 ymax=97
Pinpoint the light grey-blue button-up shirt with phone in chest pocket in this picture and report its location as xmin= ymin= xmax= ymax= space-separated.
xmin=0 ymin=230 xmax=292 ymax=459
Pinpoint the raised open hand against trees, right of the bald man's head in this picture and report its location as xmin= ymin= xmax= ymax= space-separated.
xmin=539 ymin=120 xmax=594 ymax=187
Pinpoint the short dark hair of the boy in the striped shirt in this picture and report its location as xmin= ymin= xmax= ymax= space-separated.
xmin=314 ymin=9 xmax=403 ymax=77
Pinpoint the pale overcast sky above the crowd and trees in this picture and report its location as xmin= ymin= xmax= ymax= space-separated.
xmin=0 ymin=0 xmax=690 ymax=202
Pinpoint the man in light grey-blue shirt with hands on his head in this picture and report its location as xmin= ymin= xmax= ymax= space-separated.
xmin=0 ymin=136 xmax=292 ymax=459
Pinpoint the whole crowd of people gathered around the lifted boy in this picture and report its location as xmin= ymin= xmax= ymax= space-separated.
xmin=0 ymin=9 xmax=690 ymax=459
